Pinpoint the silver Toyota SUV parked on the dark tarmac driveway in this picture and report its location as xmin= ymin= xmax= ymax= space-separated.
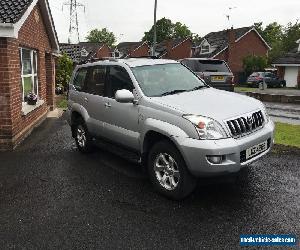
xmin=67 ymin=58 xmax=274 ymax=199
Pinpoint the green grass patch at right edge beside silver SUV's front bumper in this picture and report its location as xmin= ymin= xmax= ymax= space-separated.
xmin=275 ymin=122 xmax=300 ymax=148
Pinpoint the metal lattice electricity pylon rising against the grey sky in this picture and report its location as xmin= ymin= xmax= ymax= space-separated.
xmin=62 ymin=0 xmax=85 ymax=43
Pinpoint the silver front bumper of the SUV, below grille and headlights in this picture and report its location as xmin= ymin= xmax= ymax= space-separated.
xmin=175 ymin=121 xmax=274 ymax=176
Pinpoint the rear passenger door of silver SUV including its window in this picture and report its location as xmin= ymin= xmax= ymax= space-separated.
xmin=84 ymin=65 xmax=106 ymax=137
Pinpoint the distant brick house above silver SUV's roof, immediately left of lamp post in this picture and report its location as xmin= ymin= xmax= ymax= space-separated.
xmin=112 ymin=42 xmax=150 ymax=58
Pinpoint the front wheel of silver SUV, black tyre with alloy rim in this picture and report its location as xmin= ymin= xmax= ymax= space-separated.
xmin=147 ymin=140 xmax=197 ymax=200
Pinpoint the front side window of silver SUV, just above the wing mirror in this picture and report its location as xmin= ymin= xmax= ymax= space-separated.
xmin=106 ymin=66 xmax=134 ymax=98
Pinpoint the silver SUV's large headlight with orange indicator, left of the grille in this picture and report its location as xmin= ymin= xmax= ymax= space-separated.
xmin=183 ymin=115 xmax=228 ymax=140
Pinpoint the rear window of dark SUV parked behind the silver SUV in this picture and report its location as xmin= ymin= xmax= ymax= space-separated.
xmin=190 ymin=60 xmax=230 ymax=72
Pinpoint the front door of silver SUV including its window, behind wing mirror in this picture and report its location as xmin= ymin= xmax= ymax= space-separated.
xmin=103 ymin=66 xmax=140 ymax=150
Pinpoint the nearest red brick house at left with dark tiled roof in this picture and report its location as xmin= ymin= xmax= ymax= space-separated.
xmin=0 ymin=0 xmax=59 ymax=151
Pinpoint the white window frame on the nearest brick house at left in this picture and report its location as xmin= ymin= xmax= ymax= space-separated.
xmin=19 ymin=48 xmax=39 ymax=103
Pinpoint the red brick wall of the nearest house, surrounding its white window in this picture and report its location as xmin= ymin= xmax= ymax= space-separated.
xmin=0 ymin=3 xmax=54 ymax=151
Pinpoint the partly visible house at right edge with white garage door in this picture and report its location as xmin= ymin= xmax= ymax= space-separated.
xmin=273 ymin=39 xmax=300 ymax=88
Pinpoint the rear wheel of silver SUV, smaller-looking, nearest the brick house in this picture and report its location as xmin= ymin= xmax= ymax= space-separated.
xmin=74 ymin=118 xmax=93 ymax=153
